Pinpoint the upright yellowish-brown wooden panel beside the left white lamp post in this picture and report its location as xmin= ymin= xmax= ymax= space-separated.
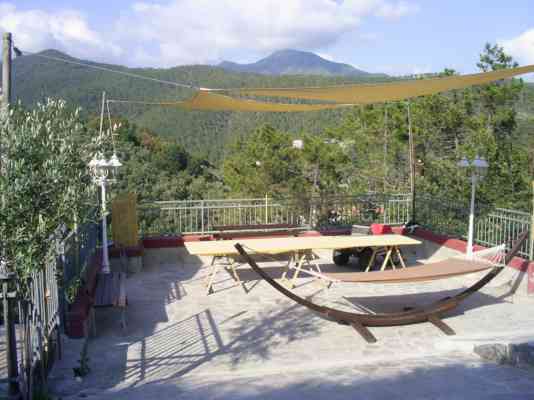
xmin=111 ymin=193 xmax=139 ymax=247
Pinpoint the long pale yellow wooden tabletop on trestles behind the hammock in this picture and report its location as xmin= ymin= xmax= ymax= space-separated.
xmin=185 ymin=235 xmax=421 ymax=256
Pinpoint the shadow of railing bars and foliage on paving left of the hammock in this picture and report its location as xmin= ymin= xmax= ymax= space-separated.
xmin=51 ymin=260 xmax=319 ymax=397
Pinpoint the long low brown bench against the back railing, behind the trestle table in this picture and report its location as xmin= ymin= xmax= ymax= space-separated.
xmin=213 ymin=224 xmax=309 ymax=240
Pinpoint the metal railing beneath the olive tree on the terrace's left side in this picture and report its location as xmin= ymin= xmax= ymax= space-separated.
xmin=0 ymin=217 xmax=99 ymax=398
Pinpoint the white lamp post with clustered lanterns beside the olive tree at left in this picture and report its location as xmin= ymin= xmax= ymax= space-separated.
xmin=89 ymin=153 xmax=122 ymax=274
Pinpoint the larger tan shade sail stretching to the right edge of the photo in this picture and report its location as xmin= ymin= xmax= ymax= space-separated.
xmin=232 ymin=65 xmax=534 ymax=104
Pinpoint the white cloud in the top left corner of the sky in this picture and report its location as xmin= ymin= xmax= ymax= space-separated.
xmin=0 ymin=3 xmax=121 ymax=58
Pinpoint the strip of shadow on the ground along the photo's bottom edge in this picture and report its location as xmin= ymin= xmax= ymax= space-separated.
xmin=74 ymin=359 xmax=534 ymax=400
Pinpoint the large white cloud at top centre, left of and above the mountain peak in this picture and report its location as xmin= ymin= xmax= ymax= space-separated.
xmin=114 ymin=0 xmax=417 ymax=66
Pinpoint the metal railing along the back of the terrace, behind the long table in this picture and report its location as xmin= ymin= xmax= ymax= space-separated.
xmin=139 ymin=193 xmax=410 ymax=236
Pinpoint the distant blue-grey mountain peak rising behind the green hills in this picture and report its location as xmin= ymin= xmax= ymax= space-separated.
xmin=218 ymin=49 xmax=380 ymax=77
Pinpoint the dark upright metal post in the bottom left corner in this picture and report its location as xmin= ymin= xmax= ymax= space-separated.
xmin=2 ymin=274 xmax=20 ymax=399
